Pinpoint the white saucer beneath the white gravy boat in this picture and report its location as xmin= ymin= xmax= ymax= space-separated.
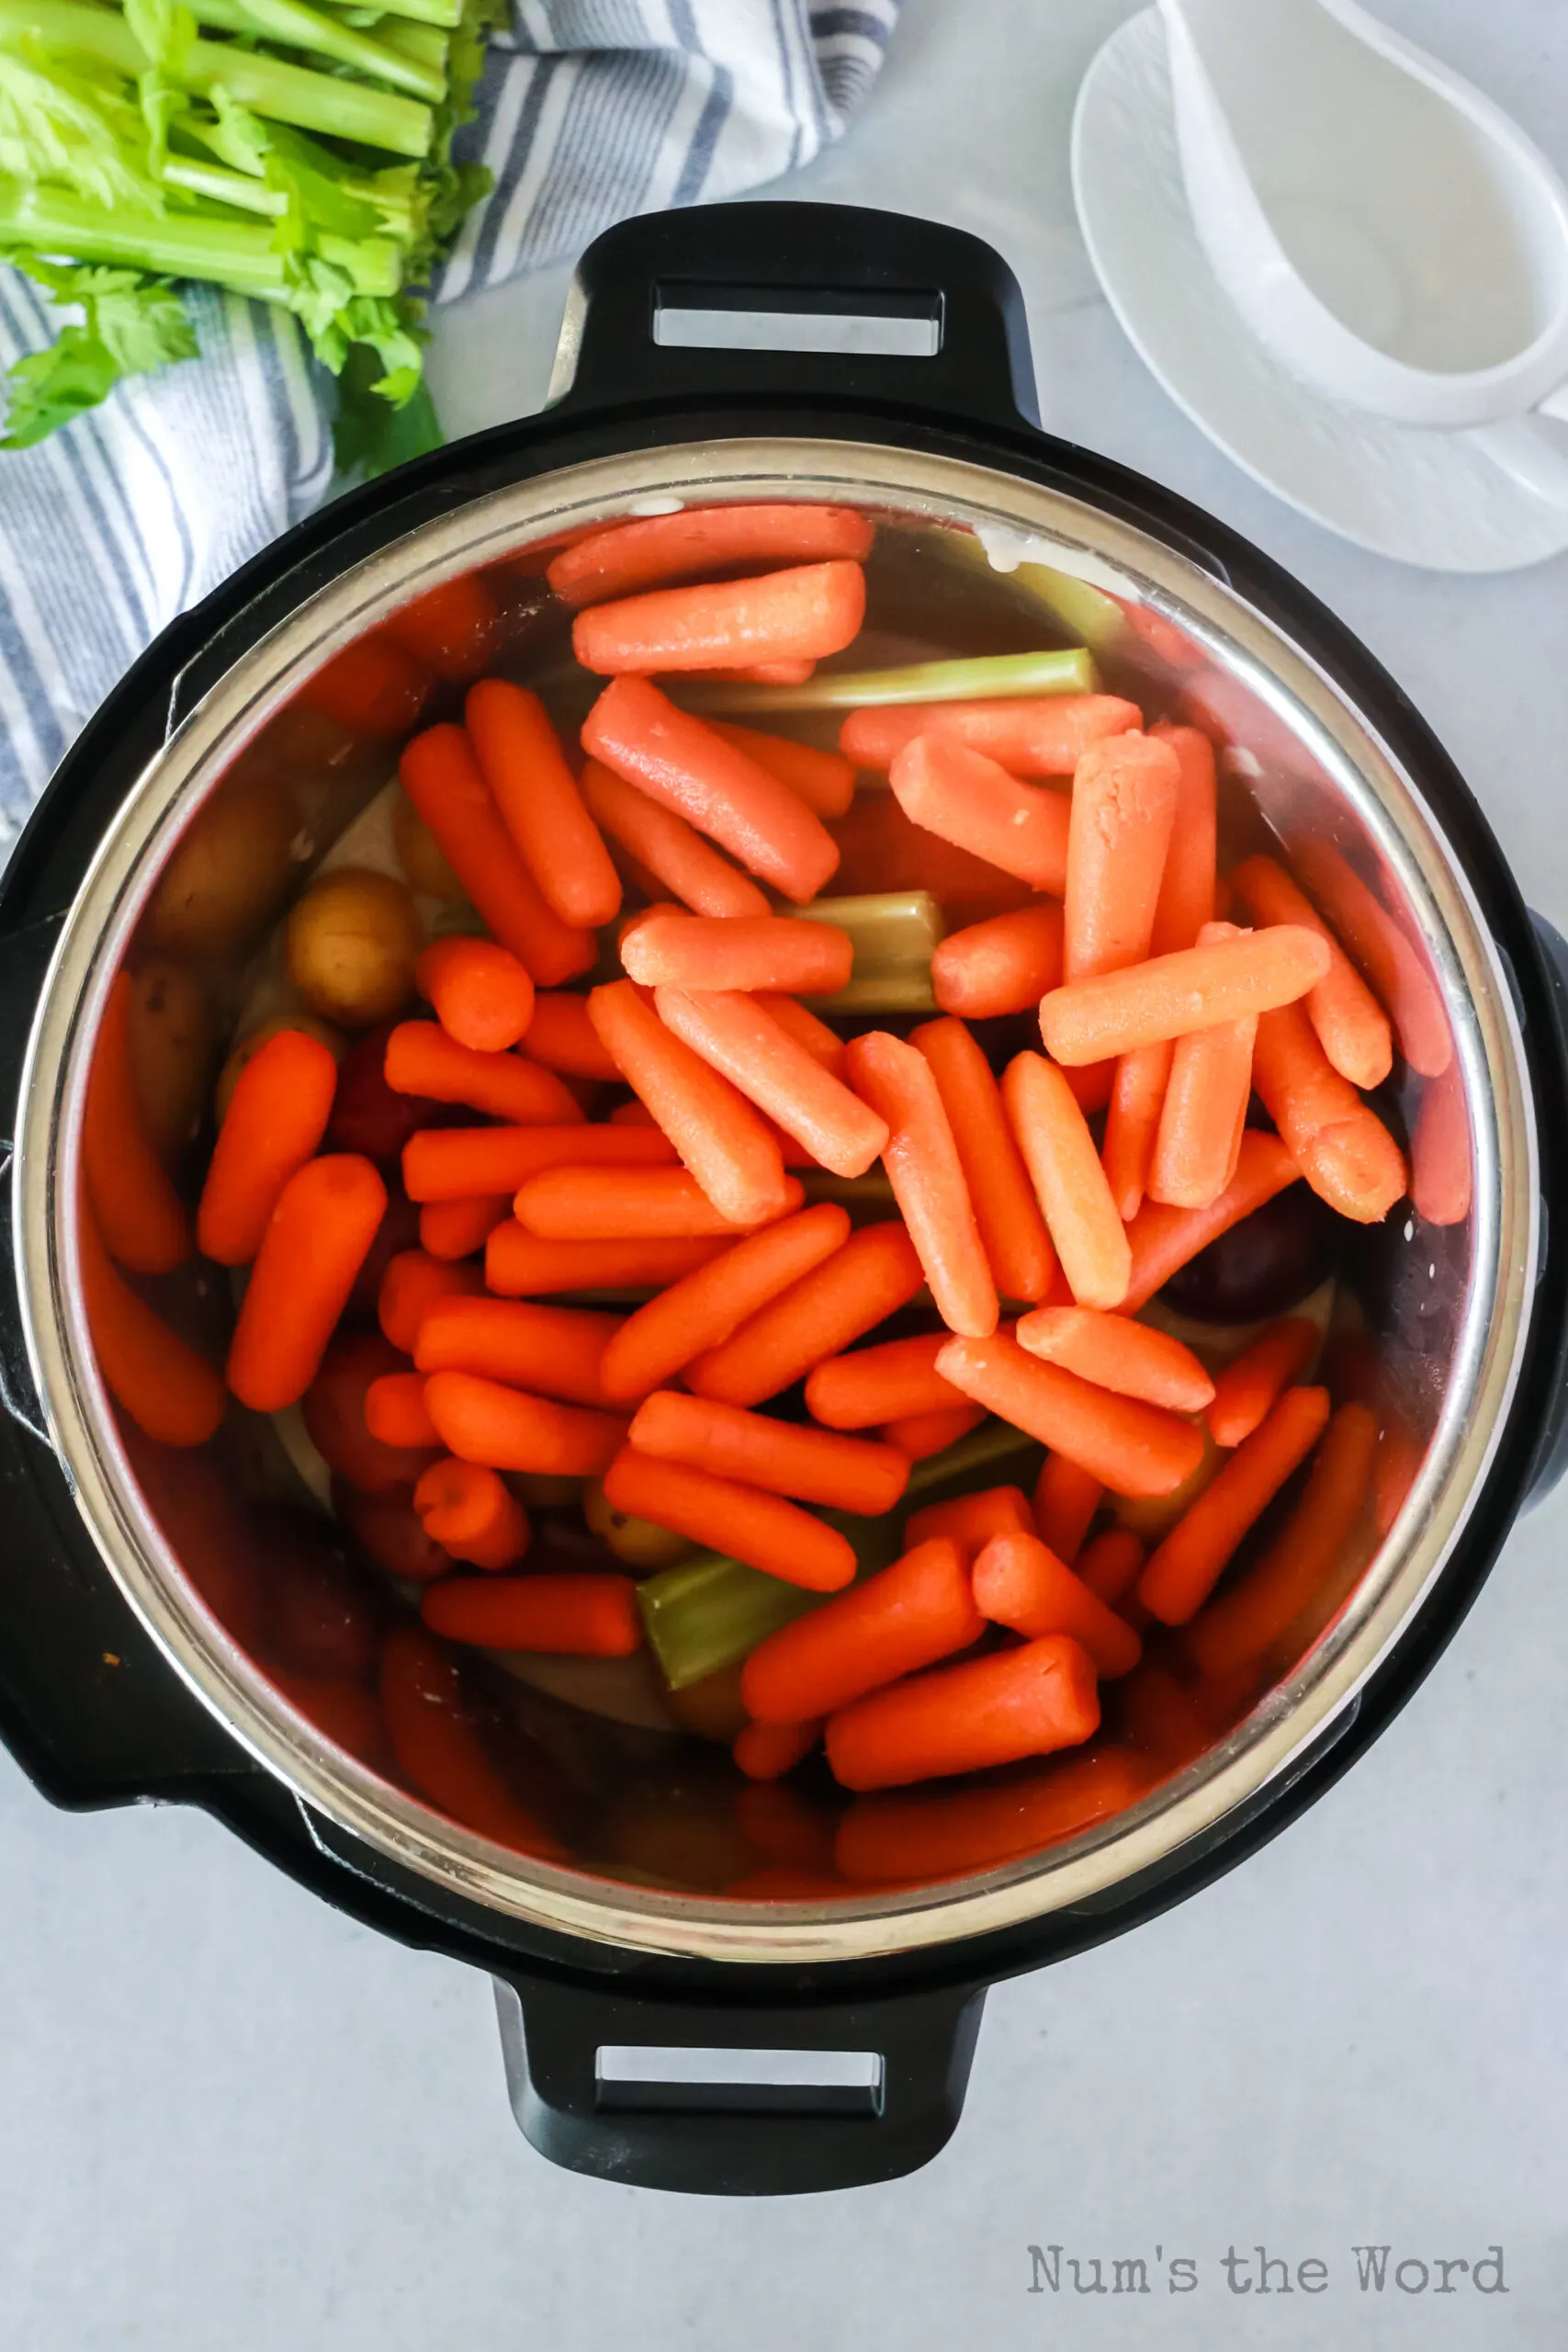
xmin=1072 ymin=9 xmax=1568 ymax=571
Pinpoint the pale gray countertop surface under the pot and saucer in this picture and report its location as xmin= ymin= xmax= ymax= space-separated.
xmin=0 ymin=0 xmax=1568 ymax=2352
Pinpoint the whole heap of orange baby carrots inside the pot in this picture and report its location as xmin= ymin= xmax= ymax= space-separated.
xmin=83 ymin=505 xmax=1470 ymax=1790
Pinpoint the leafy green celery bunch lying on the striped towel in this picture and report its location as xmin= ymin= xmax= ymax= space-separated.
xmin=0 ymin=0 xmax=503 ymax=473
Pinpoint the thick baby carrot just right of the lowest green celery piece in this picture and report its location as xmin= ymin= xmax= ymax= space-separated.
xmin=740 ymin=1536 xmax=985 ymax=1724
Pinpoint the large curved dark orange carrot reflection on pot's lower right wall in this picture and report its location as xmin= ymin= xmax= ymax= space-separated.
xmin=1187 ymin=1404 xmax=1378 ymax=1675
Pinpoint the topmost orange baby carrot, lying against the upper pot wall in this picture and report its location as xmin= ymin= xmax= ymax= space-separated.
xmin=546 ymin=499 xmax=874 ymax=605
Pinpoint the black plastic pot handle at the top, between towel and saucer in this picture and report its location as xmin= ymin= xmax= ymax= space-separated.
xmin=550 ymin=202 xmax=1039 ymax=428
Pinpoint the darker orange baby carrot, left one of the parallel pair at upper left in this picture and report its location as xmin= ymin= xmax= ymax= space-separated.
xmin=398 ymin=724 xmax=594 ymax=988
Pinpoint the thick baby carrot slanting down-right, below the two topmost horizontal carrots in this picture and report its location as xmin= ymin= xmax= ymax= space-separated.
xmin=583 ymin=677 xmax=840 ymax=912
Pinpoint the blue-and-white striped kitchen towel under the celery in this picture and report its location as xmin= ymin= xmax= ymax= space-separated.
xmin=0 ymin=0 xmax=898 ymax=864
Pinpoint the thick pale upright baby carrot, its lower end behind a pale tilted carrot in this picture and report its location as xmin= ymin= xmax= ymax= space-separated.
xmin=1063 ymin=734 xmax=1178 ymax=981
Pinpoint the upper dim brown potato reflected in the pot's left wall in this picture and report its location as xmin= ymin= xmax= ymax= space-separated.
xmin=146 ymin=783 xmax=301 ymax=957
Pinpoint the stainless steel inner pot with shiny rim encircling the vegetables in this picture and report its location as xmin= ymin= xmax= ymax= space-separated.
xmin=17 ymin=437 xmax=1538 ymax=1964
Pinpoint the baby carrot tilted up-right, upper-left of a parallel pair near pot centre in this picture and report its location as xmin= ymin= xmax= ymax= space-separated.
xmin=600 ymin=1202 xmax=849 ymax=1402
